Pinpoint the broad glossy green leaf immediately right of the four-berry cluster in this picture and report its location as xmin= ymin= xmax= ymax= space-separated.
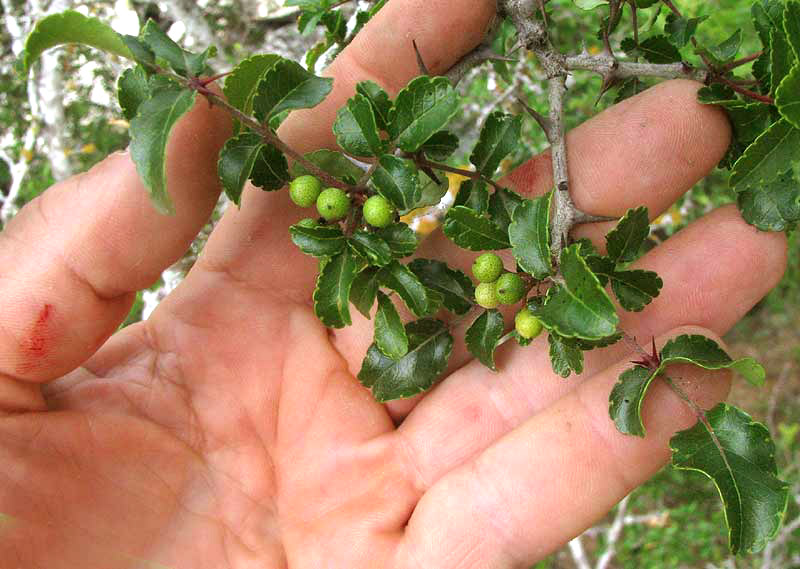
xmin=534 ymin=245 xmax=619 ymax=340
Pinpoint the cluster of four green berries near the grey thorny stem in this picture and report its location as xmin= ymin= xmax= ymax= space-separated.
xmin=472 ymin=253 xmax=542 ymax=340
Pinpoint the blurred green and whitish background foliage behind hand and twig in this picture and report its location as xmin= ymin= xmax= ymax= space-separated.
xmin=0 ymin=0 xmax=800 ymax=569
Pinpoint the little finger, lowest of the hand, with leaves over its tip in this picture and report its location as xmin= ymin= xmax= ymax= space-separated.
xmin=396 ymin=328 xmax=729 ymax=569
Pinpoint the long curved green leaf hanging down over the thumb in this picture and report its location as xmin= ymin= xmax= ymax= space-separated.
xmin=130 ymin=84 xmax=196 ymax=213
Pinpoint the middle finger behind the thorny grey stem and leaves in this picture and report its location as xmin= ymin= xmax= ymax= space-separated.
xmin=336 ymin=77 xmax=730 ymax=398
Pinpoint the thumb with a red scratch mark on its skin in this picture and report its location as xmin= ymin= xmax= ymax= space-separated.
xmin=0 ymin=95 xmax=230 ymax=392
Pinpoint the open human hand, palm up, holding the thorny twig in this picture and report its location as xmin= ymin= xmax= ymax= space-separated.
xmin=0 ymin=0 xmax=785 ymax=569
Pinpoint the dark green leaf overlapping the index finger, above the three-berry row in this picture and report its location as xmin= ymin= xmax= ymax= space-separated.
xmin=253 ymin=59 xmax=333 ymax=122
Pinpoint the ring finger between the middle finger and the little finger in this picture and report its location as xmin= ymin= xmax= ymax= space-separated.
xmin=398 ymin=207 xmax=786 ymax=492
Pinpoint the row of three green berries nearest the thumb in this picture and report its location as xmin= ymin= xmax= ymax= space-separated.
xmin=289 ymin=175 xmax=395 ymax=228
